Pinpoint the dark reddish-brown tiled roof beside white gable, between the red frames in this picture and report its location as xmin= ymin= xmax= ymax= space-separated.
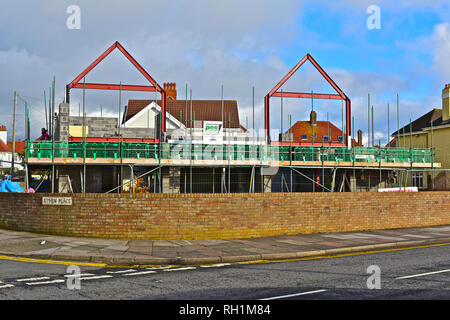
xmin=125 ymin=99 xmax=240 ymax=128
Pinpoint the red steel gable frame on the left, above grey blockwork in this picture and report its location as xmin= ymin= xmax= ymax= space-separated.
xmin=66 ymin=41 xmax=166 ymax=132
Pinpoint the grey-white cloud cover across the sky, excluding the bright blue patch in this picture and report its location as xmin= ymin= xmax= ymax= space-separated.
xmin=0 ymin=0 xmax=450 ymax=144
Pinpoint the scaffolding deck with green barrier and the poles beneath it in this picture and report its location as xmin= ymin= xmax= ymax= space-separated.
xmin=26 ymin=141 xmax=439 ymax=193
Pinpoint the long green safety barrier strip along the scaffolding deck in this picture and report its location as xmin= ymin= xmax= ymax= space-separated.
xmin=26 ymin=141 xmax=434 ymax=163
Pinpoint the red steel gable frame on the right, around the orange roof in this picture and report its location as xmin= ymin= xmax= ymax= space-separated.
xmin=264 ymin=53 xmax=351 ymax=146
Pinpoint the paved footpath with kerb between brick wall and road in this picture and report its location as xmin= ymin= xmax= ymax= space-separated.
xmin=0 ymin=225 xmax=450 ymax=266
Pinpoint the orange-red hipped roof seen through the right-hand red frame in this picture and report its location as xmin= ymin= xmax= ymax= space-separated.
xmin=286 ymin=121 xmax=358 ymax=145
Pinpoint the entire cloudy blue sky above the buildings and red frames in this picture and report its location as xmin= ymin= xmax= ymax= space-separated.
xmin=0 ymin=0 xmax=450 ymax=144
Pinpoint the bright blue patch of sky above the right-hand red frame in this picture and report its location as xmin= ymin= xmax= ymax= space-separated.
xmin=280 ymin=4 xmax=442 ymax=89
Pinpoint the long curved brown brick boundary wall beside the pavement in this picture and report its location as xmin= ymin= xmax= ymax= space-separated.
xmin=0 ymin=191 xmax=450 ymax=239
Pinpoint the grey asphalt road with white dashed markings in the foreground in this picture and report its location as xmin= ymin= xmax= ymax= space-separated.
xmin=0 ymin=245 xmax=450 ymax=300
